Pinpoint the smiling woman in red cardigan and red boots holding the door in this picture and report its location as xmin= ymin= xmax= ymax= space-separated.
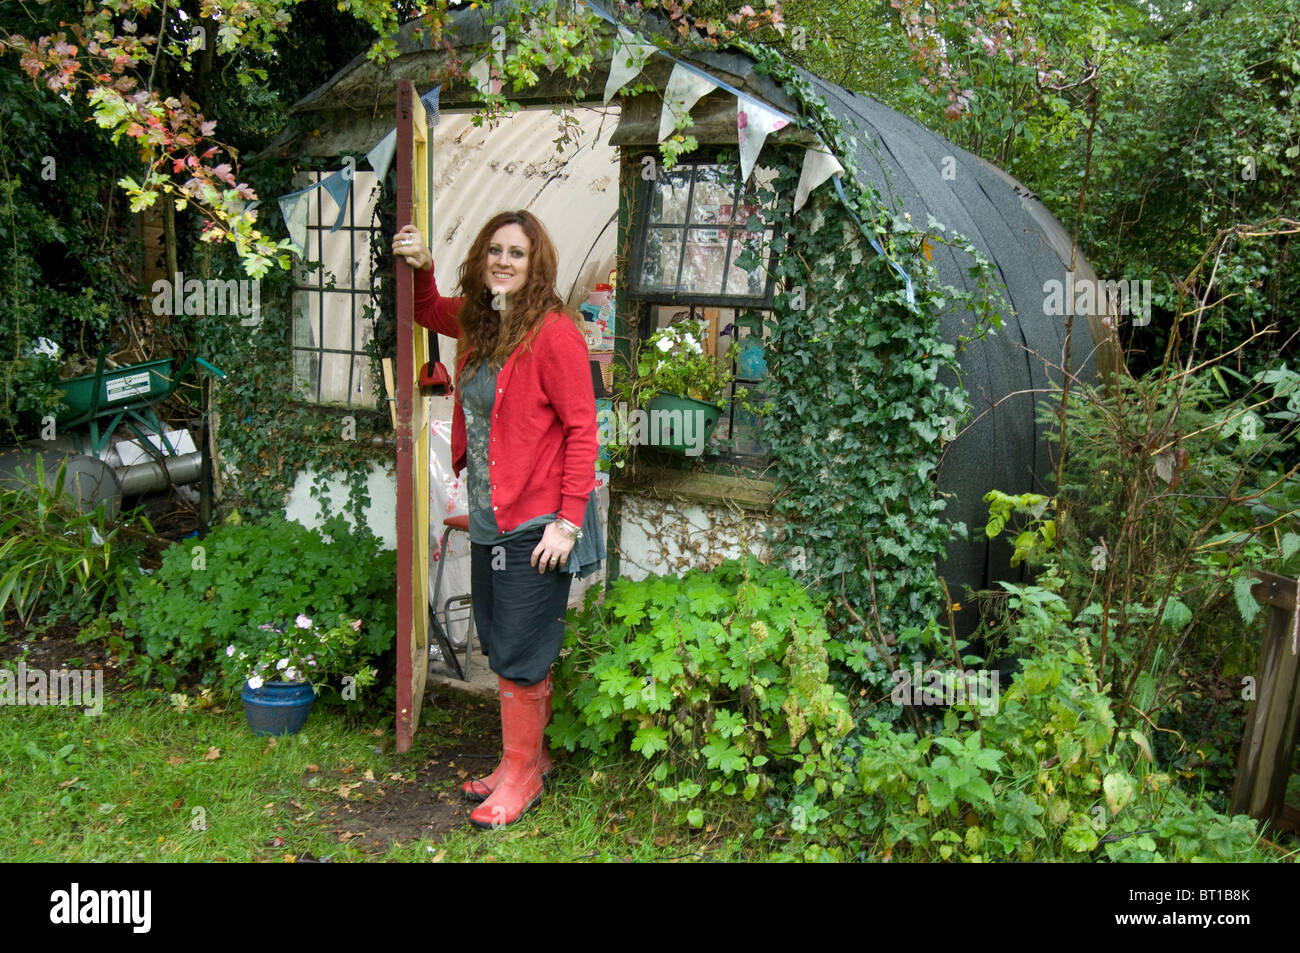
xmin=393 ymin=211 xmax=603 ymax=827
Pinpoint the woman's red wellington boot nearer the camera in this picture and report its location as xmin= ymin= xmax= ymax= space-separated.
xmin=469 ymin=676 xmax=551 ymax=827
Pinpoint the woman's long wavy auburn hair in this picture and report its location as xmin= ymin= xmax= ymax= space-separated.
xmin=456 ymin=209 xmax=576 ymax=376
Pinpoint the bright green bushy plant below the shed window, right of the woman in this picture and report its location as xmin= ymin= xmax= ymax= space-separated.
xmin=549 ymin=556 xmax=853 ymax=826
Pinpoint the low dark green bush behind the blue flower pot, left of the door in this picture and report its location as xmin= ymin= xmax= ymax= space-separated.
xmin=114 ymin=517 xmax=397 ymax=688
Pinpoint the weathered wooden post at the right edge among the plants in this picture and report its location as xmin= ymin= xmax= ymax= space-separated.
xmin=1231 ymin=571 xmax=1300 ymax=828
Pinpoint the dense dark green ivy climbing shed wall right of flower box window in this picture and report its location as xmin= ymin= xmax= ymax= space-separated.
xmin=748 ymin=47 xmax=1000 ymax=718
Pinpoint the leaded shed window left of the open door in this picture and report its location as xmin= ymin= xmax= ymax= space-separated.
xmin=293 ymin=169 xmax=378 ymax=407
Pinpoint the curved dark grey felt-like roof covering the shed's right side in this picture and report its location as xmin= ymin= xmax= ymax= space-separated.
xmin=805 ymin=74 xmax=1105 ymax=595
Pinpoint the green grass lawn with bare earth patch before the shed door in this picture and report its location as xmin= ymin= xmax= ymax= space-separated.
xmin=0 ymin=689 xmax=764 ymax=862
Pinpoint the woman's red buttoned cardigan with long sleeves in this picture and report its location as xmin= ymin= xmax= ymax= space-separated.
xmin=415 ymin=268 xmax=597 ymax=533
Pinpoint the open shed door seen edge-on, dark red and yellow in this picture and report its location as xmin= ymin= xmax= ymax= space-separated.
xmin=394 ymin=79 xmax=433 ymax=751
